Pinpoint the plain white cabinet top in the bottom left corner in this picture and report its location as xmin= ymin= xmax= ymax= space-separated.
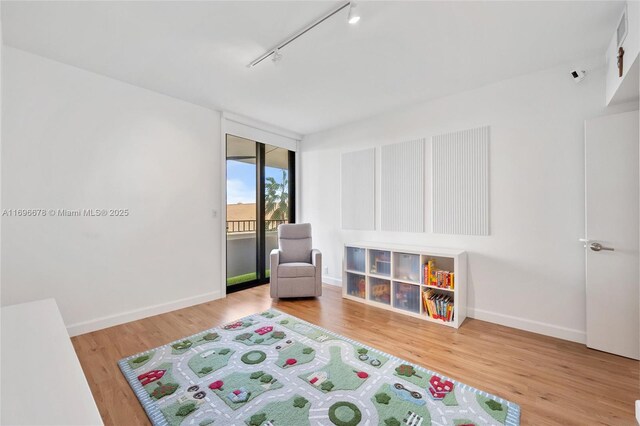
xmin=0 ymin=299 xmax=102 ymax=426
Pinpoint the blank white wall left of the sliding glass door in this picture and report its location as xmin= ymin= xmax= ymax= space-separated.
xmin=2 ymin=47 xmax=221 ymax=333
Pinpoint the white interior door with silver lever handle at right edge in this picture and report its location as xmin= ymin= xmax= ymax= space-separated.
xmin=585 ymin=111 xmax=640 ymax=359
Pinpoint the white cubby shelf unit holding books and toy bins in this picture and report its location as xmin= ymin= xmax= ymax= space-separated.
xmin=342 ymin=242 xmax=467 ymax=328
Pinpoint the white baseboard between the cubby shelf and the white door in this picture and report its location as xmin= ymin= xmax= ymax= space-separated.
xmin=467 ymin=307 xmax=587 ymax=344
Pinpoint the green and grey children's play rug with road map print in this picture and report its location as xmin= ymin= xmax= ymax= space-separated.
xmin=118 ymin=310 xmax=520 ymax=426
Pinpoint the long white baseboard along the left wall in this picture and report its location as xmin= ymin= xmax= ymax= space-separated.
xmin=67 ymin=291 xmax=221 ymax=337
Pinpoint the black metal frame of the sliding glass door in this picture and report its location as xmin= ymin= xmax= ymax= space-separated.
xmin=224 ymin=133 xmax=296 ymax=294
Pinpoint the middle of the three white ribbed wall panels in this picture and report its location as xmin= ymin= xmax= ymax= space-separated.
xmin=380 ymin=139 xmax=425 ymax=232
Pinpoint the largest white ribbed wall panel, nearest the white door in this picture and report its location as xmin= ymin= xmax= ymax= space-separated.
xmin=431 ymin=126 xmax=489 ymax=235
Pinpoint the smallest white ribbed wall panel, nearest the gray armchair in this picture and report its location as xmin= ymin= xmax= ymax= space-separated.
xmin=340 ymin=148 xmax=376 ymax=230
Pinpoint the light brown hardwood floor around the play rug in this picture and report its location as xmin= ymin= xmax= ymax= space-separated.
xmin=72 ymin=286 xmax=640 ymax=426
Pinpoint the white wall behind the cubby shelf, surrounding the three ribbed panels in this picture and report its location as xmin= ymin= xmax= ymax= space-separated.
xmin=300 ymin=59 xmax=637 ymax=342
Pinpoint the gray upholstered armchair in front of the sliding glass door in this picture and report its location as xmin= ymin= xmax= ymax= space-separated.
xmin=271 ymin=223 xmax=322 ymax=298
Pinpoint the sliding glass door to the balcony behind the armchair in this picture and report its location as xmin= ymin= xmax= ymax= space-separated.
xmin=226 ymin=135 xmax=295 ymax=293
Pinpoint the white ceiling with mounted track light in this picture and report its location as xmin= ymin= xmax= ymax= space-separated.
xmin=2 ymin=1 xmax=623 ymax=134
